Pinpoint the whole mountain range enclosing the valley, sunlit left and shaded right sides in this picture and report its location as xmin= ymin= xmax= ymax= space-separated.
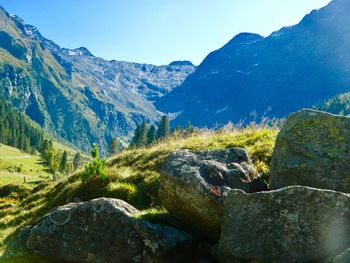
xmin=0 ymin=0 xmax=350 ymax=151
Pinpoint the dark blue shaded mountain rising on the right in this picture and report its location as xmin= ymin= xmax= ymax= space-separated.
xmin=156 ymin=0 xmax=350 ymax=126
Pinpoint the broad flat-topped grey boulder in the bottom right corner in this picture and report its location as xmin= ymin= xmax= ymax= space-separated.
xmin=216 ymin=186 xmax=350 ymax=263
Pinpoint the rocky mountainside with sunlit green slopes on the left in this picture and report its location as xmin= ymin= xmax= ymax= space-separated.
xmin=0 ymin=8 xmax=195 ymax=153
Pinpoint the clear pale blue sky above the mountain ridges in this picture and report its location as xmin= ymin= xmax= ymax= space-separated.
xmin=0 ymin=0 xmax=330 ymax=65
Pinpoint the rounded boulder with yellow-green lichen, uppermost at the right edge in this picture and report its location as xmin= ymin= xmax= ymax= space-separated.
xmin=270 ymin=110 xmax=350 ymax=192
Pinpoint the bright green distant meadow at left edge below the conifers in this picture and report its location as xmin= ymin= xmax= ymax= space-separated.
xmin=0 ymin=144 xmax=50 ymax=186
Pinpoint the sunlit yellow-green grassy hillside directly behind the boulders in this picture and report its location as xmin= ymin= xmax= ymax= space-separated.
xmin=0 ymin=128 xmax=277 ymax=260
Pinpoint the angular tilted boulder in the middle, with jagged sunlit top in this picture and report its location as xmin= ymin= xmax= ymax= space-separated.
xmin=159 ymin=148 xmax=267 ymax=240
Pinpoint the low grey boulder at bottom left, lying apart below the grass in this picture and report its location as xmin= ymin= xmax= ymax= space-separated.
xmin=26 ymin=198 xmax=194 ymax=263
